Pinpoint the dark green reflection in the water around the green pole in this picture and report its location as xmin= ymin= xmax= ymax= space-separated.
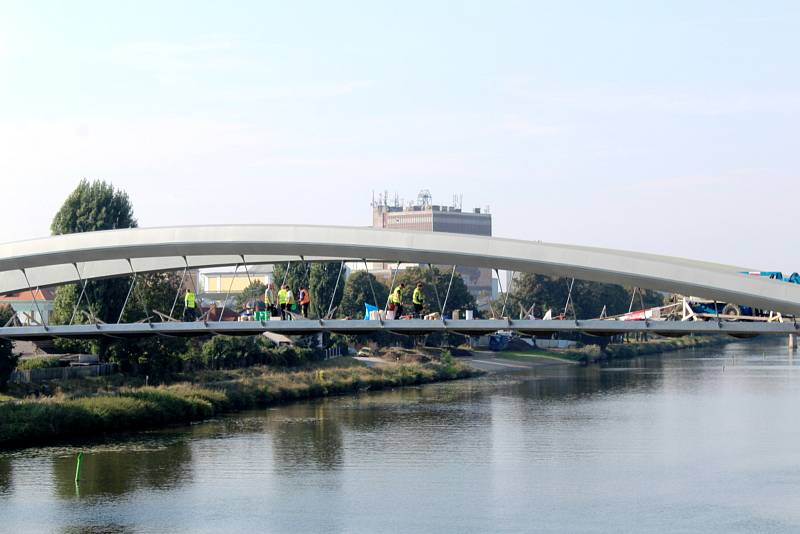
xmin=53 ymin=441 xmax=192 ymax=498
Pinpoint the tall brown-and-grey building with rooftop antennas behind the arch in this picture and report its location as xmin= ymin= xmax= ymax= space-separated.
xmin=372 ymin=190 xmax=496 ymax=306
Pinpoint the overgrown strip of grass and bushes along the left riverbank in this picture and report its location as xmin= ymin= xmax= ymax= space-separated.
xmin=0 ymin=356 xmax=481 ymax=449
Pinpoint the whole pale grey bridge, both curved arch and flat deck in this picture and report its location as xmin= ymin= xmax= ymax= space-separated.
xmin=0 ymin=225 xmax=800 ymax=339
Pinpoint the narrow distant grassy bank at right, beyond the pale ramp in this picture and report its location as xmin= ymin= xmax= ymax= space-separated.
xmin=498 ymin=336 xmax=733 ymax=363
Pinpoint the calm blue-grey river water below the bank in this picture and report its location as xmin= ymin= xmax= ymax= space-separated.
xmin=0 ymin=338 xmax=800 ymax=533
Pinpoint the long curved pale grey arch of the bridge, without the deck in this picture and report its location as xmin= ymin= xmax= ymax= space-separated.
xmin=0 ymin=225 xmax=800 ymax=315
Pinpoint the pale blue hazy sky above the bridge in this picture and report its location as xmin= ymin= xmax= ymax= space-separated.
xmin=0 ymin=0 xmax=800 ymax=272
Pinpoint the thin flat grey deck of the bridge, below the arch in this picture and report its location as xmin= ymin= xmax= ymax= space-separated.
xmin=0 ymin=319 xmax=800 ymax=340
